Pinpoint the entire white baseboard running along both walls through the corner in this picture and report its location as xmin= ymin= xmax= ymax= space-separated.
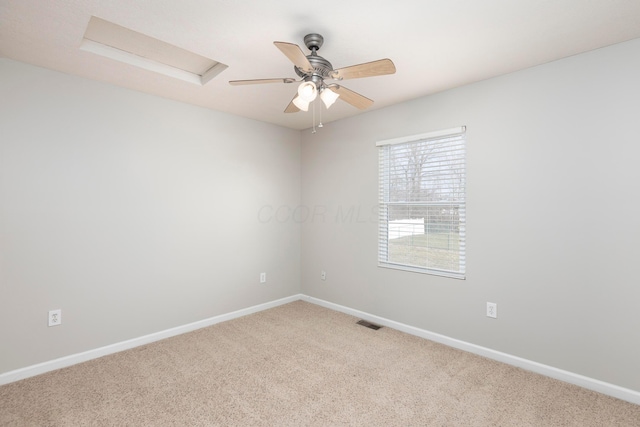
xmin=0 ymin=294 xmax=640 ymax=405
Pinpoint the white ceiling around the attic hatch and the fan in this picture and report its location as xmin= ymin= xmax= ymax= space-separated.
xmin=0 ymin=0 xmax=640 ymax=129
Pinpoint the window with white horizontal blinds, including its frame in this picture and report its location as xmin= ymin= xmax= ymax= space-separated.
xmin=376 ymin=127 xmax=466 ymax=279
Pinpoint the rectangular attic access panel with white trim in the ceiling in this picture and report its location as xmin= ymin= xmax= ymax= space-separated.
xmin=80 ymin=16 xmax=228 ymax=85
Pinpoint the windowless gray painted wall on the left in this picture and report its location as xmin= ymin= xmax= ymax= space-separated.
xmin=0 ymin=59 xmax=300 ymax=373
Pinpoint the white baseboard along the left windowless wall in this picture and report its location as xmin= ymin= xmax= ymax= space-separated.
xmin=0 ymin=294 xmax=302 ymax=385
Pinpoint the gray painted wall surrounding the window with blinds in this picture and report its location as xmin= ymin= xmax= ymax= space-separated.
xmin=302 ymin=40 xmax=640 ymax=390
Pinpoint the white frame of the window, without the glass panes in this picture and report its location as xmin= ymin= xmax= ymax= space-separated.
xmin=376 ymin=126 xmax=466 ymax=279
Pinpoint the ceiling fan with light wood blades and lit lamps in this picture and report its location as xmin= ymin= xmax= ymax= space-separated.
xmin=229 ymin=33 xmax=396 ymax=113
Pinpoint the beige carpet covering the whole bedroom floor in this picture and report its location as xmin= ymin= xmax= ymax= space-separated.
xmin=0 ymin=301 xmax=640 ymax=427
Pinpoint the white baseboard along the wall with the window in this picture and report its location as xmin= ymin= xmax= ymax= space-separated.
xmin=301 ymin=295 xmax=640 ymax=405
